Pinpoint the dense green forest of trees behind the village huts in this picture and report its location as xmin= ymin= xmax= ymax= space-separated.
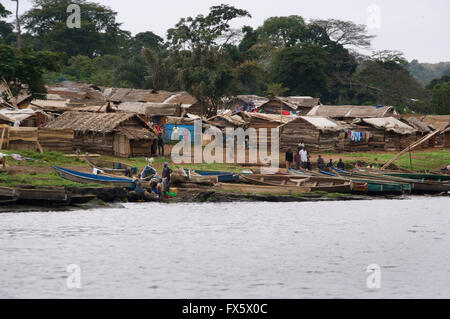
xmin=0 ymin=0 xmax=450 ymax=114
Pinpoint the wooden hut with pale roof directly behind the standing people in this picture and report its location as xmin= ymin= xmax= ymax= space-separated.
xmin=279 ymin=116 xmax=345 ymax=152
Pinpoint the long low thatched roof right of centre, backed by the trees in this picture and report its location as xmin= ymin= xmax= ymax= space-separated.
xmin=308 ymin=105 xmax=397 ymax=118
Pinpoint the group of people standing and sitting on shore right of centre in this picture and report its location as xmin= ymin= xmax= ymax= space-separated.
xmin=286 ymin=142 xmax=345 ymax=171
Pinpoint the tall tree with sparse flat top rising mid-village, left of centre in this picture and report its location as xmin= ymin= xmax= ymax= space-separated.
xmin=167 ymin=4 xmax=250 ymax=115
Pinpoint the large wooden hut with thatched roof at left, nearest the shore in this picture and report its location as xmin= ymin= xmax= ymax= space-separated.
xmin=46 ymin=112 xmax=157 ymax=157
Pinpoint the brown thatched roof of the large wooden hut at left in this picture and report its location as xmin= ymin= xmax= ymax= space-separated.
xmin=46 ymin=112 xmax=156 ymax=139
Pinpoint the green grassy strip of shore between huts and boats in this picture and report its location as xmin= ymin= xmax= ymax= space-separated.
xmin=0 ymin=149 xmax=450 ymax=187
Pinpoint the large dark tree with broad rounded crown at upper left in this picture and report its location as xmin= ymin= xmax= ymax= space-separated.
xmin=22 ymin=0 xmax=130 ymax=57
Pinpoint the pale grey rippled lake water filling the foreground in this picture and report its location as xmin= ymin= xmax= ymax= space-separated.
xmin=0 ymin=197 xmax=450 ymax=298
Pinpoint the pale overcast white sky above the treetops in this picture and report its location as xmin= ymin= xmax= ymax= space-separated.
xmin=1 ymin=0 xmax=450 ymax=63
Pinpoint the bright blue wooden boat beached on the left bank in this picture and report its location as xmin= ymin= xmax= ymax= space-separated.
xmin=53 ymin=166 xmax=134 ymax=188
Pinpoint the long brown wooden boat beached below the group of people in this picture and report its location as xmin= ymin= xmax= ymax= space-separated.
xmin=240 ymin=174 xmax=353 ymax=193
